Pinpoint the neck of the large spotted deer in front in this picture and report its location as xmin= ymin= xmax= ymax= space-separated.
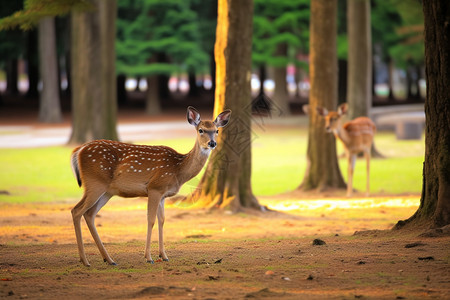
xmin=180 ymin=141 xmax=211 ymax=183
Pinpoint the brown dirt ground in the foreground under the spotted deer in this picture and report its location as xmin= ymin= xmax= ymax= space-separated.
xmin=0 ymin=193 xmax=450 ymax=299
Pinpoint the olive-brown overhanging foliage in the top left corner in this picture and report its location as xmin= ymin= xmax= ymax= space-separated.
xmin=0 ymin=0 xmax=93 ymax=30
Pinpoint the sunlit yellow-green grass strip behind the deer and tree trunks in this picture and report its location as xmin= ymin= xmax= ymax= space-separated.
xmin=0 ymin=129 xmax=424 ymax=203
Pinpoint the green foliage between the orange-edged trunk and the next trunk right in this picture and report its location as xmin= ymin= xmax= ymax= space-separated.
xmin=252 ymin=0 xmax=310 ymax=67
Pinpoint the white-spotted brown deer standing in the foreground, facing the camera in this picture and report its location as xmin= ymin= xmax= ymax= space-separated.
xmin=72 ymin=107 xmax=231 ymax=266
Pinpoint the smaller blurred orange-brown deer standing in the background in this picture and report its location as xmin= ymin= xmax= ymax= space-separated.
xmin=316 ymin=103 xmax=376 ymax=197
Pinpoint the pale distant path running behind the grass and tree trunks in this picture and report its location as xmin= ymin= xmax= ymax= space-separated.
xmin=0 ymin=109 xmax=307 ymax=148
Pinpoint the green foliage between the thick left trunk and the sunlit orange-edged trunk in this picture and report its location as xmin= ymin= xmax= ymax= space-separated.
xmin=116 ymin=0 xmax=209 ymax=76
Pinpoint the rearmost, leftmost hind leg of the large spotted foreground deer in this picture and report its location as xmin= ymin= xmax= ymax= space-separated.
xmin=72 ymin=192 xmax=108 ymax=267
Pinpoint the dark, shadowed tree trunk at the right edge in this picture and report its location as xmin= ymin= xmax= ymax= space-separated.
xmin=396 ymin=0 xmax=450 ymax=228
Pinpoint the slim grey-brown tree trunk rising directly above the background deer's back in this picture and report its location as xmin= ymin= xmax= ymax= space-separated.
xmin=347 ymin=0 xmax=372 ymax=120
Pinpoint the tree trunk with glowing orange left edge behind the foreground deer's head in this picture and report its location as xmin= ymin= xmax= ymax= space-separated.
xmin=185 ymin=0 xmax=261 ymax=211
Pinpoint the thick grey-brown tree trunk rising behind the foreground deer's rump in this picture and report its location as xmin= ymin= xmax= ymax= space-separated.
xmin=69 ymin=0 xmax=118 ymax=144
